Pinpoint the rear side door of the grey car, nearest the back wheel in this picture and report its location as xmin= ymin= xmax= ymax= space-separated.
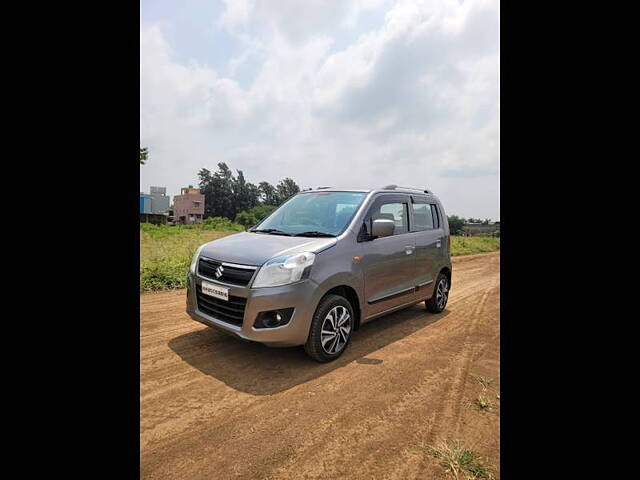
xmin=410 ymin=195 xmax=446 ymax=298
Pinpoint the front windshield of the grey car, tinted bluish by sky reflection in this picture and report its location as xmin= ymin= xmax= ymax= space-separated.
xmin=252 ymin=192 xmax=366 ymax=237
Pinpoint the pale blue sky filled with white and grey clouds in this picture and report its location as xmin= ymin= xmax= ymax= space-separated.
xmin=140 ymin=0 xmax=500 ymax=220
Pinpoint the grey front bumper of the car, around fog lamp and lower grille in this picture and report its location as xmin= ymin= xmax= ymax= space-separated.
xmin=187 ymin=272 xmax=319 ymax=347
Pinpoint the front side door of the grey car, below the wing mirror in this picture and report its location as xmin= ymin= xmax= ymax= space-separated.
xmin=360 ymin=194 xmax=416 ymax=319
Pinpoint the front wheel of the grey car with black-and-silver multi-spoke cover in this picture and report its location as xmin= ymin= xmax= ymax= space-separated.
xmin=304 ymin=295 xmax=354 ymax=363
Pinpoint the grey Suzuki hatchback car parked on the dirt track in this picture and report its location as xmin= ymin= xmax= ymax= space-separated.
xmin=187 ymin=185 xmax=451 ymax=362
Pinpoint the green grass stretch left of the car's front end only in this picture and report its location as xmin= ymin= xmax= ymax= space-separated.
xmin=140 ymin=217 xmax=244 ymax=292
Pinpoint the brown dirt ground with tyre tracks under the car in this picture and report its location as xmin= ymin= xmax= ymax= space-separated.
xmin=140 ymin=252 xmax=500 ymax=479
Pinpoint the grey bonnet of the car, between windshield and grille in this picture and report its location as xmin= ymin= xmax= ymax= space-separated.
xmin=200 ymin=232 xmax=337 ymax=265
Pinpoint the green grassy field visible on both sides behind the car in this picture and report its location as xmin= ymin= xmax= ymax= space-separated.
xmin=140 ymin=226 xmax=500 ymax=292
